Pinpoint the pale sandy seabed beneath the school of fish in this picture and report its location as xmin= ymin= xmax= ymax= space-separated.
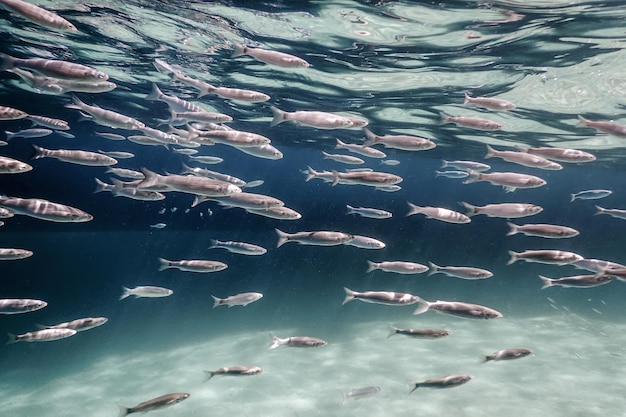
xmin=0 ymin=313 xmax=626 ymax=417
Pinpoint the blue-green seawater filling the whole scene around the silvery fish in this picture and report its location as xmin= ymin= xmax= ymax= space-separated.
xmin=0 ymin=1 xmax=626 ymax=417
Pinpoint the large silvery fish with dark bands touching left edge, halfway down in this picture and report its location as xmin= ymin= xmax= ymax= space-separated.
xmin=0 ymin=196 xmax=93 ymax=223
